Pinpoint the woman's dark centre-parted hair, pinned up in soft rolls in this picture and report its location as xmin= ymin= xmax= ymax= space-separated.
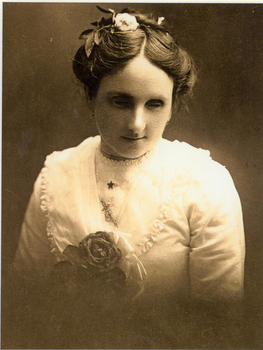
xmin=73 ymin=9 xmax=196 ymax=108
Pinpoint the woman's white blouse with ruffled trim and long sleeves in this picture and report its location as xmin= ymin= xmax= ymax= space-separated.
xmin=14 ymin=136 xmax=245 ymax=300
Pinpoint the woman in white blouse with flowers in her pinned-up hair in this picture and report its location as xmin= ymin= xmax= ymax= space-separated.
xmin=14 ymin=9 xmax=245 ymax=342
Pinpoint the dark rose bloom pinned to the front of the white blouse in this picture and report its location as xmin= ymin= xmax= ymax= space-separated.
xmin=79 ymin=231 xmax=122 ymax=272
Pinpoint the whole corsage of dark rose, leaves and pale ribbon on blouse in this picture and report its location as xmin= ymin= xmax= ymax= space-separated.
xmin=52 ymin=231 xmax=146 ymax=306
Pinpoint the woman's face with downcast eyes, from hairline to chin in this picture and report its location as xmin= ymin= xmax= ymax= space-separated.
xmin=94 ymin=56 xmax=173 ymax=158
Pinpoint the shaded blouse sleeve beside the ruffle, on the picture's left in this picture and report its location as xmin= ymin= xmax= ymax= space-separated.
xmin=13 ymin=175 xmax=55 ymax=279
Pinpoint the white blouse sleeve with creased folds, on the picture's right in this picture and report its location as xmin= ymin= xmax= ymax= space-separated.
xmin=185 ymin=161 xmax=245 ymax=301
